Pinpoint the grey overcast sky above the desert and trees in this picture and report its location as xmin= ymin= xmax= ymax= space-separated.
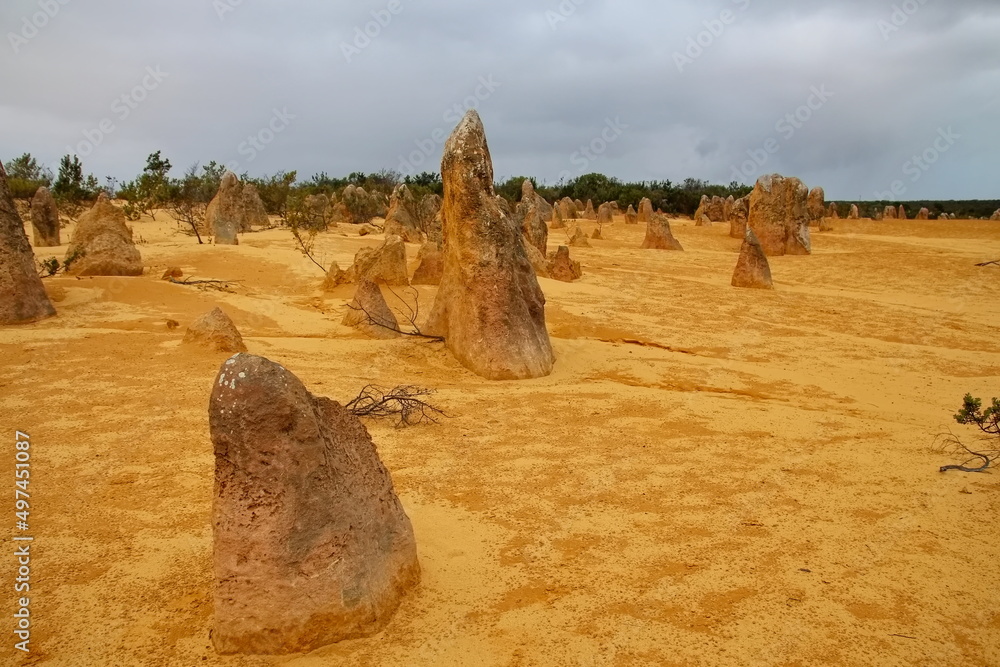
xmin=0 ymin=0 xmax=1000 ymax=200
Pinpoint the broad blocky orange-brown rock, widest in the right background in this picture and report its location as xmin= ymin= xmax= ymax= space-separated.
xmin=747 ymin=174 xmax=812 ymax=257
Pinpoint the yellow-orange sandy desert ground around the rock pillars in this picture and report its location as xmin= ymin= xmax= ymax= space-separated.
xmin=0 ymin=214 xmax=1000 ymax=667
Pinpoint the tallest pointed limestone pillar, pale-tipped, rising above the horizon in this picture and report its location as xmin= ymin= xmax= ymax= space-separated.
xmin=425 ymin=110 xmax=555 ymax=380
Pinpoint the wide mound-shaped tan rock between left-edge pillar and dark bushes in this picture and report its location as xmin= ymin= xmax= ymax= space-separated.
xmin=66 ymin=193 xmax=142 ymax=276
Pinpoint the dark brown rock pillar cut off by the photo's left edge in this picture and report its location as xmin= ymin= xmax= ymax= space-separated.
xmin=0 ymin=164 xmax=58 ymax=324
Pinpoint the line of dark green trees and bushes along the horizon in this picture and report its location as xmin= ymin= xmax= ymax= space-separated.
xmin=6 ymin=151 xmax=1000 ymax=219
